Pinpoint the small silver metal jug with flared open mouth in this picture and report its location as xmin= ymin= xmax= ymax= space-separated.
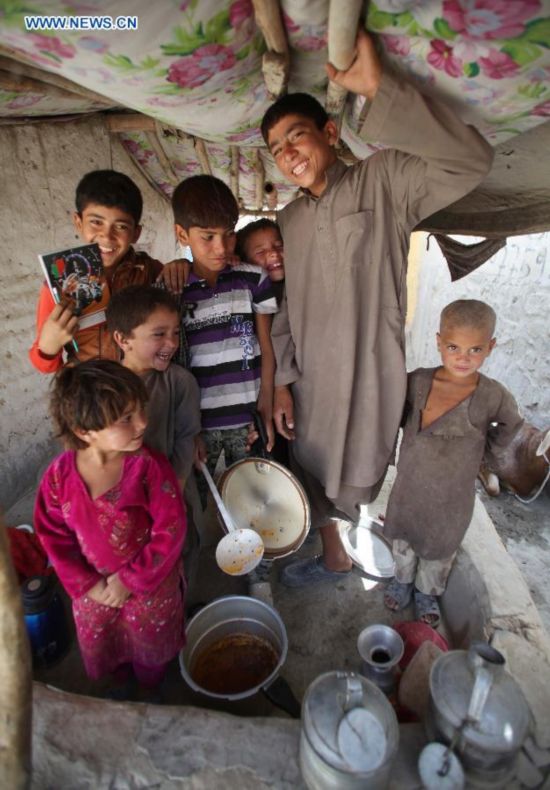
xmin=357 ymin=624 xmax=405 ymax=694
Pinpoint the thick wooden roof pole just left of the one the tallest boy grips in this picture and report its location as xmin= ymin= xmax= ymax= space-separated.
xmin=252 ymin=0 xmax=290 ymax=99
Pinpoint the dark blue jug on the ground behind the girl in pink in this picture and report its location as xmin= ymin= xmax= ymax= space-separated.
xmin=21 ymin=575 xmax=70 ymax=667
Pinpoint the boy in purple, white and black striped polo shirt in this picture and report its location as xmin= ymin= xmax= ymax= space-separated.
xmin=172 ymin=175 xmax=277 ymax=501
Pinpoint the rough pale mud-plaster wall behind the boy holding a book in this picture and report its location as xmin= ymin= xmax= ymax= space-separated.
xmin=0 ymin=118 xmax=175 ymax=510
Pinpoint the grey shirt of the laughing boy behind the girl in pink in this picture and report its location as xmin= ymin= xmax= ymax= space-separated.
xmin=142 ymin=364 xmax=201 ymax=478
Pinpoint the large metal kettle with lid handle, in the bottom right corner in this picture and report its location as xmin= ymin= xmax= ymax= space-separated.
xmin=427 ymin=642 xmax=531 ymax=788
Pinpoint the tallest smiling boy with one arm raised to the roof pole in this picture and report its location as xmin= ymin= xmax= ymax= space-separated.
xmin=262 ymin=32 xmax=492 ymax=586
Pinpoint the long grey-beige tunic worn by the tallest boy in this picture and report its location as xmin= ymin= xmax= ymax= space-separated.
xmin=272 ymin=73 xmax=492 ymax=499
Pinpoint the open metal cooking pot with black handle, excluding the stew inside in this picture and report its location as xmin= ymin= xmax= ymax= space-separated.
xmin=179 ymin=595 xmax=300 ymax=718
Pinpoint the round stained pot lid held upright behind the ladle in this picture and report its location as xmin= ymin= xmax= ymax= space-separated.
xmin=220 ymin=458 xmax=310 ymax=552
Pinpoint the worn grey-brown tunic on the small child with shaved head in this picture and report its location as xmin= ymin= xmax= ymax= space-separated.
xmin=384 ymin=368 xmax=523 ymax=560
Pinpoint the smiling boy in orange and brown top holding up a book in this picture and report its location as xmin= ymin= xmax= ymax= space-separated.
xmin=29 ymin=170 xmax=185 ymax=373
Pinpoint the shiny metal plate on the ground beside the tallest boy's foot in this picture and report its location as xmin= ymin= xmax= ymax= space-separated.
xmin=338 ymin=519 xmax=395 ymax=581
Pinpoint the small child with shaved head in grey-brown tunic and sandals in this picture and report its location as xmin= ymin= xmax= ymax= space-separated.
xmin=384 ymin=299 xmax=523 ymax=626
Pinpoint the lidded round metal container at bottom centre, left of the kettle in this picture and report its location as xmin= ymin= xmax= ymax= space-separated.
xmin=300 ymin=672 xmax=399 ymax=790
